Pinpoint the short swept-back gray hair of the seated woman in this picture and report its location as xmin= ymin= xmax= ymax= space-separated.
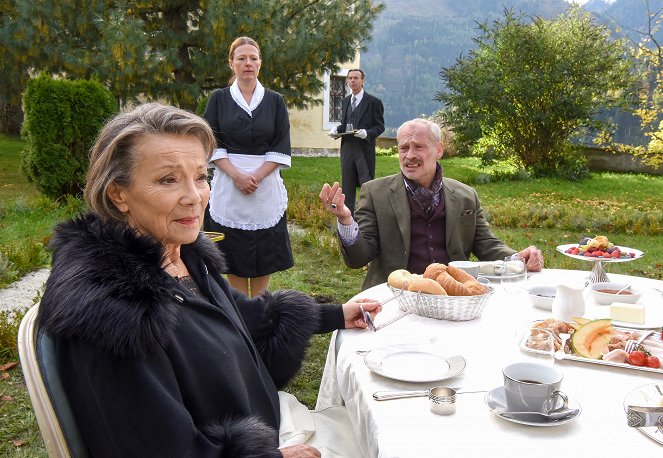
xmin=84 ymin=103 xmax=216 ymax=221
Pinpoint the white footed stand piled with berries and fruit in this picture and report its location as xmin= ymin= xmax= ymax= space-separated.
xmin=557 ymin=235 xmax=644 ymax=283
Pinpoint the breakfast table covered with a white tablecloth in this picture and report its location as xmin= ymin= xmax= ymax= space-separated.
xmin=316 ymin=269 xmax=663 ymax=458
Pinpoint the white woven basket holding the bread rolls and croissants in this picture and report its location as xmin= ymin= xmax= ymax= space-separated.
xmin=389 ymin=285 xmax=495 ymax=321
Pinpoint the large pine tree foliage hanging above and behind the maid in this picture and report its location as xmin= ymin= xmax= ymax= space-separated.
xmin=13 ymin=0 xmax=383 ymax=109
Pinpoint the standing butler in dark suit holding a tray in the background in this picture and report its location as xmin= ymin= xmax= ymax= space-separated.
xmin=329 ymin=68 xmax=384 ymax=213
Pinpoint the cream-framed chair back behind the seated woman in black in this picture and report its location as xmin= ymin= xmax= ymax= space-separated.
xmin=18 ymin=304 xmax=89 ymax=458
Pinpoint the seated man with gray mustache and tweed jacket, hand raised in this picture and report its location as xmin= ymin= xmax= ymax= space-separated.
xmin=320 ymin=119 xmax=543 ymax=289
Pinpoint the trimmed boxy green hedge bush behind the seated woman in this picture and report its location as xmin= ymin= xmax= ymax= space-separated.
xmin=21 ymin=74 xmax=117 ymax=199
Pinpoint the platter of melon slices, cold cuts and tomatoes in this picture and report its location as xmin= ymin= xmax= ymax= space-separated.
xmin=520 ymin=318 xmax=663 ymax=373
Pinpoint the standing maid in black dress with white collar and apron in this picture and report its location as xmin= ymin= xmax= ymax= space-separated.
xmin=204 ymin=37 xmax=294 ymax=295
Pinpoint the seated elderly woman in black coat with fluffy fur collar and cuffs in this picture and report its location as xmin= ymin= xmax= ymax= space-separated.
xmin=39 ymin=104 xmax=380 ymax=458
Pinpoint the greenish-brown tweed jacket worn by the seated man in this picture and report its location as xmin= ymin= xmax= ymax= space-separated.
xmin=341 ymin=173 xmax=516 ymax=289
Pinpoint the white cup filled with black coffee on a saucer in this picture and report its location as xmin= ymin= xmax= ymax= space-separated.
xmin=502 ymin=362 xmax=568 ymax=414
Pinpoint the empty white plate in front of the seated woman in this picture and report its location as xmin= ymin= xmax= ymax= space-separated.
xmin=364 ymin=344 xmax=465 ymax=382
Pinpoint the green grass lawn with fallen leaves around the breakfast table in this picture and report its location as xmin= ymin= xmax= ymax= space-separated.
xmin=0 ymin=136 xmax=663 ymax=457
